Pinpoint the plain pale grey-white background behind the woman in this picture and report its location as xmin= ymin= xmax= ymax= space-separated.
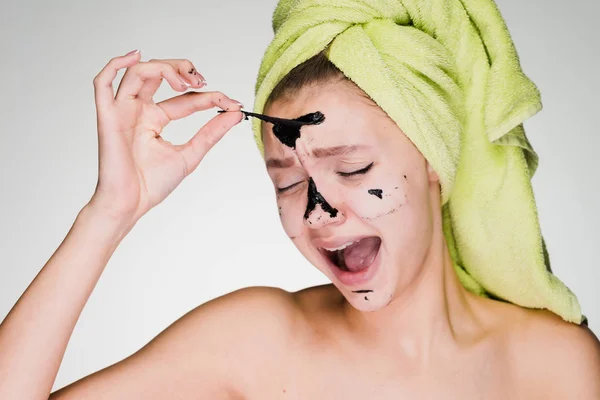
xmin=0 ymin=0 xmax=600 ymax=388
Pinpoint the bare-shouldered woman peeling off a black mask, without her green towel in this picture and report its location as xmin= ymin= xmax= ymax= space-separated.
xmin=0 ymin=2 xmax=600 ymax=400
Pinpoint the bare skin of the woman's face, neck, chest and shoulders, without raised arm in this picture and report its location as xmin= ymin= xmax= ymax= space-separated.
xmin=51 ymin=78 xmax=600 ymax=400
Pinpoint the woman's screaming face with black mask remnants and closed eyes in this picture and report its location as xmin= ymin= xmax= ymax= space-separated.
xmin=263 ymin=81 xmax=439 ymax=311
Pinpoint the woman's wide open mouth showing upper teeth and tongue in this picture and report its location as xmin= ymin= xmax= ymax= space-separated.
xmin=319 ymin=236 xmax=381 ymax=272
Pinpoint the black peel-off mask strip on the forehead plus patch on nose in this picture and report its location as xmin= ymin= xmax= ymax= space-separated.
xmin=219 ymin=110 xmax=338 ymax=219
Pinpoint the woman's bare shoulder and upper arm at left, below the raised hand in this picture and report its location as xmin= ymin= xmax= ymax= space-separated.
xmin=51 ymin=286 xmax=297 ymax=400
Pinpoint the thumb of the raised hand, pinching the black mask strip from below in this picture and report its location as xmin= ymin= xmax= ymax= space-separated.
xmin=175 ymin=112 xmax=244 ymax=176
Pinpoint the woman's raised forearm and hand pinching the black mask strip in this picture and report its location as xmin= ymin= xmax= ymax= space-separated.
xmin=0 ymin=52 xmax=242 ymax=400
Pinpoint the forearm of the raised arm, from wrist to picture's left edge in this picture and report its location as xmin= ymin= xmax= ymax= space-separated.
xmin=0 ymin=207 xmax=131 ymax=399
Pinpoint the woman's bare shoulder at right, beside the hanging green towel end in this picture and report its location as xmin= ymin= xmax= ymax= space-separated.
xmin=507 ymin=309 xmax=600 ymax=399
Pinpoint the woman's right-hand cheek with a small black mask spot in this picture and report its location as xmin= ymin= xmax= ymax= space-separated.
xmin=346 ymin=176 xmax=408 ymax=220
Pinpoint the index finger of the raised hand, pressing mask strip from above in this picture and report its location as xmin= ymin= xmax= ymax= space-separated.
xmin=156 ymin=92 xmax=243 ymax=121
